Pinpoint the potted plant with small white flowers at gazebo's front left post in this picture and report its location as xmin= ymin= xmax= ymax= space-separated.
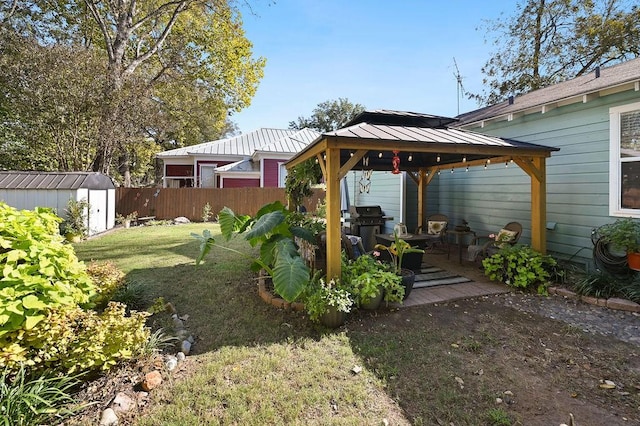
xmin=304 ymin=278 xmax=353 ymax=328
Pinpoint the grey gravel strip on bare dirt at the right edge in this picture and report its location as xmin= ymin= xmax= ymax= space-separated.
xmin=495 ymin=293 xmax=640 ymax=346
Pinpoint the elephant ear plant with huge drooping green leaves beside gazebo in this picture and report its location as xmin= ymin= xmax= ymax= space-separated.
xmin=191 ymin=201 xmax=315 ymax=302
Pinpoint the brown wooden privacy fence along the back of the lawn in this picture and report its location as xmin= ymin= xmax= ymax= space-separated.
xmin=116 ymin=188 xmax=325 ymax=221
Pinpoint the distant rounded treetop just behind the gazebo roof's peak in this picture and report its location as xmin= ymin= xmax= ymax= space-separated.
xmin=289 ymin=98 xmax=365 ymax=132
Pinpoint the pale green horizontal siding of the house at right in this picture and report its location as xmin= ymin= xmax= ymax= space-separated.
xmin=456 ymin=91 xmax=640 ymax=262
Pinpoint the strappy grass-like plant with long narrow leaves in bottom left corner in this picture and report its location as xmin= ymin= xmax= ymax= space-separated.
xmin=0 ymin=368 xmax=83 ymax=426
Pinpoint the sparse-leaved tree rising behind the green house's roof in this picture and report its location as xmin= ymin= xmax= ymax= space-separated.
xmin=471 ymin=0 xmax=640 ymax=104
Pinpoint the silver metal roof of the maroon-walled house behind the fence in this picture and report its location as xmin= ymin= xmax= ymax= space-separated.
xmin=157 ymin=128 xmax=298 ymax=158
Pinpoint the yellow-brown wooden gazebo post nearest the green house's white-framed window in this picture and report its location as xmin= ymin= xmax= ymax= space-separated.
xmin=530 ymin=157 xmax=547 ymax=254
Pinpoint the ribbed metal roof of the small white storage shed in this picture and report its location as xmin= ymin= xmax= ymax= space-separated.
xmin=0 ymin=171 xmax=115 ymax=189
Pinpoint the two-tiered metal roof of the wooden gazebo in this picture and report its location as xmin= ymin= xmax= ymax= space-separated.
xmin=290 ymin=110 xmax=558 ymax=171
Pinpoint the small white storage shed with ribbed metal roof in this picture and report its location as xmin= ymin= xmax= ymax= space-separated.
xmin=0 ymin=171 xmax=116 ymax=235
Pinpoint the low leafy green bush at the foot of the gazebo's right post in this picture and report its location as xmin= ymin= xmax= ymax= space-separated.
xmin=482 ymin=245 xmax=557 ymax=294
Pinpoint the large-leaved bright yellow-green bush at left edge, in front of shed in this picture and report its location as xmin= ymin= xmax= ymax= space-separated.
xmin=0 ymin=203 xmax=95 ymax=340
